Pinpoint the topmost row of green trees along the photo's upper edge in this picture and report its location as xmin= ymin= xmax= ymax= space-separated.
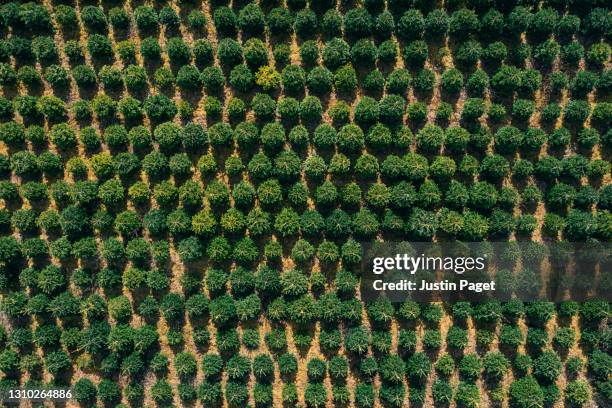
xmin=0 ymin=0 xmax=610 ymax=39
